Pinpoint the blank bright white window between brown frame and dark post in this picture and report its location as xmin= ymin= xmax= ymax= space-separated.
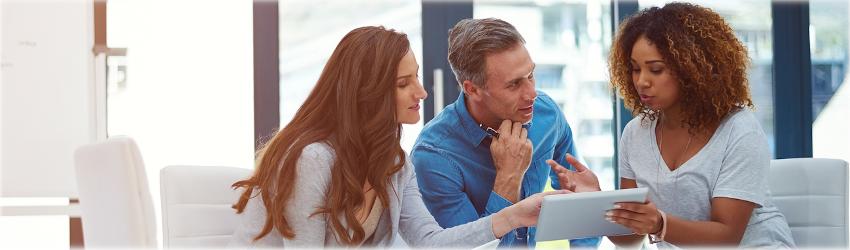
xmin=105 ymin=0 xmax=254 ymax=245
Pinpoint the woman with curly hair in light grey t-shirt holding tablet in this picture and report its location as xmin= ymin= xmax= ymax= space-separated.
xmin=606 ymin=3 xmax=794 ymax=248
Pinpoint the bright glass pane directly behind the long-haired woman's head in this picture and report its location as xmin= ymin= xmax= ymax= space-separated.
xmin=279 ymin=0 xmax=422 ymax=152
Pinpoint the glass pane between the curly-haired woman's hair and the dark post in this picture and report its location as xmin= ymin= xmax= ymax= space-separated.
xmin=638 ymin=0 xmax=776 ymax=155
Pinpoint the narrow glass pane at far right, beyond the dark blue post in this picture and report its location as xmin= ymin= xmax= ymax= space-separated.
xmin=809 ymin=0 xmax=850 ymax=161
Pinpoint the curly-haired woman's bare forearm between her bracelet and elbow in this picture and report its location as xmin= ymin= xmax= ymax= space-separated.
xmin=664 ymin=215 xmax=746 ymax=247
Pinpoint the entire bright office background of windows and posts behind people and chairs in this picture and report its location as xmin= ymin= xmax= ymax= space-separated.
xmin=0 ymin=0 xmax=850 ymax=248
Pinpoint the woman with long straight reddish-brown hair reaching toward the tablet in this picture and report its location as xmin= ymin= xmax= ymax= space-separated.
xmin=225 ymin=27 xmax=563 ymax=247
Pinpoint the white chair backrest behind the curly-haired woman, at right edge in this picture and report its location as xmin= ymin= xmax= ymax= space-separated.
xmin=770 ymin=158 xmax=848 ymax=248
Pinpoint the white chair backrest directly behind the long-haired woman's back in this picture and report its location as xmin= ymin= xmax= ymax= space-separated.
xmin=160 ymin=166 xmax=251 ymax=248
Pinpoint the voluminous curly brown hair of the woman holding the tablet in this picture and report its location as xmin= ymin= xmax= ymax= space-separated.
xmin=608 ymin=3 xmax=753 ymax=134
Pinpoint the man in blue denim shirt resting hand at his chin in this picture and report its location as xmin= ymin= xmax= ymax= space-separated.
xmin=411 ymin=18 xmax=599 ymax=247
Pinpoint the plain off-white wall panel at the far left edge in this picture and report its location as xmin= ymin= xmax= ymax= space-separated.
xmin=0 ymin=0 xmax=95 ymax=197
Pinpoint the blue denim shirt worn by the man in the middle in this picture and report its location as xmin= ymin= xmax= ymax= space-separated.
xmin=410 ymin=91 xmax=599 ymax=247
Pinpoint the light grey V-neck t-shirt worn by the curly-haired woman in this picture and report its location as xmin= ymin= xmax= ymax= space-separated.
xmin=619 ymin=110 xmax=794 ymax=247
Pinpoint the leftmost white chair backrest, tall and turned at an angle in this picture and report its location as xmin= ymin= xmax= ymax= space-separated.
xmin=74 ymin=137 xmax=156 ymax=248
